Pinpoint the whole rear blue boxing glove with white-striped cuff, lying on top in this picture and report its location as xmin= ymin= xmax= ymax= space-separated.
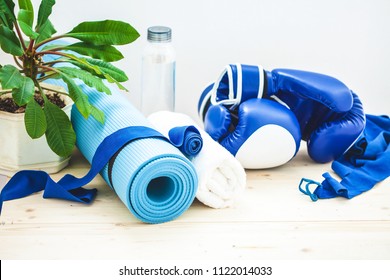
xmin=198 ymin=64 xmax=365 ymax=162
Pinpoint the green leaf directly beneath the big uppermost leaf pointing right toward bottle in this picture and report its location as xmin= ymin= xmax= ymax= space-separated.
xmin=62 ymin=42 xmax=123 ymax=62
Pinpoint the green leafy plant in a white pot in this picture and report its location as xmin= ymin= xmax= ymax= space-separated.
xmin=0 ymin=0 xmax=139 ymax=173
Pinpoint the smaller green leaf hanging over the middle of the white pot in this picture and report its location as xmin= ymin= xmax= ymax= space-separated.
xmin=24 ymin=99 xmax=47 ymax=139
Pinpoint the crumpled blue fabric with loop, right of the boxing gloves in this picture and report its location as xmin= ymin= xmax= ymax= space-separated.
xmin=299 ymin=115 xmax=390 ymax=201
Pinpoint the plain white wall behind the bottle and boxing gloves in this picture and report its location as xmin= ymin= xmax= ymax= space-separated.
xmin=3 ymin=0 xmax=390 ymax=121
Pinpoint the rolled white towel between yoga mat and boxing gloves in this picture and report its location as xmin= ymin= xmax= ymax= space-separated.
xmin=148 ymin=111 xmax=246 ymax=208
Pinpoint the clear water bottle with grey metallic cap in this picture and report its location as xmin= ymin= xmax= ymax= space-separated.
xmin=141 ymin=26 xmax=176 ymax=116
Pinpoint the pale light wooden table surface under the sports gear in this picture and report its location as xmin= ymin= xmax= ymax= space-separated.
xmin=0 ymin=147 xmax=390 ymax=260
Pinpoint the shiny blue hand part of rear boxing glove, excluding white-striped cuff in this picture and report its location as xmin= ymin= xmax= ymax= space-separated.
xmin=263 ymin=69 xmax=365 ymax=162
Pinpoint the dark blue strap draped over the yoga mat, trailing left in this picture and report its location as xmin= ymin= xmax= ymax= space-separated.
xmin=0 ymin=127 xmax=164 ymax=214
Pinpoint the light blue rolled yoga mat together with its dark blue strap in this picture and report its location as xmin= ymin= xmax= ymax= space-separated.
xmin=0 ymin=46 xmax=197 ymax=223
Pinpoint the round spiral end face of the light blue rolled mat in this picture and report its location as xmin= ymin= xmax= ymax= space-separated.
xmin=126 ymin=156 xmax=197 ymax=223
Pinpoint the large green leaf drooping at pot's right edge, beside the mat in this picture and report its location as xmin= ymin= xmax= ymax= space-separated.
xmin=43 ymin=97 xmax=76 ymax=157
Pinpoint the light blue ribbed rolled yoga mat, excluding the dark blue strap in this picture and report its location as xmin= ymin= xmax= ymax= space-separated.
xmin=68 ymin=81 xmax=198 ymax=223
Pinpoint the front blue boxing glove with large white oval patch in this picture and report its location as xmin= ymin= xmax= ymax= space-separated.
xmin=204 ymin=99 xmax=301 ymax=169
